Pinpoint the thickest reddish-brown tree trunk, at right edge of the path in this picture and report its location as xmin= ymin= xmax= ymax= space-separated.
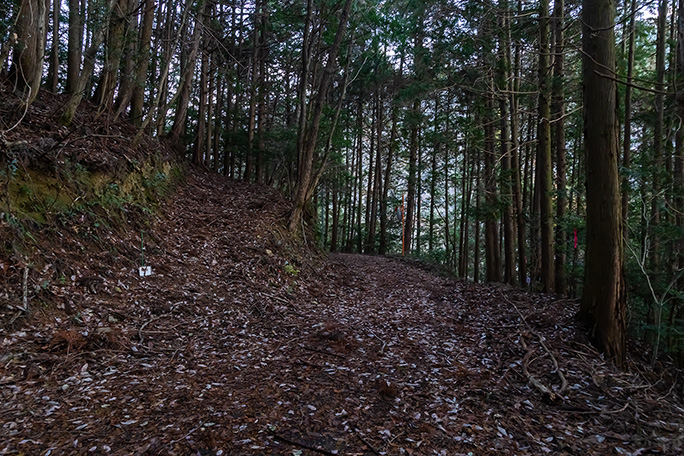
xmin=579 ymin=0 xmax=627 ymax=365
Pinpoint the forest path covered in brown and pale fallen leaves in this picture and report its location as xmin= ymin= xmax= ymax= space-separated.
xmin=0 ymin=172 xmax=684 ymax=455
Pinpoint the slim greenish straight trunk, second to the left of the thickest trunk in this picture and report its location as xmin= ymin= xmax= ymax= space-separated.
xmin=537 ymin=0 xmax=555 ymax=293
